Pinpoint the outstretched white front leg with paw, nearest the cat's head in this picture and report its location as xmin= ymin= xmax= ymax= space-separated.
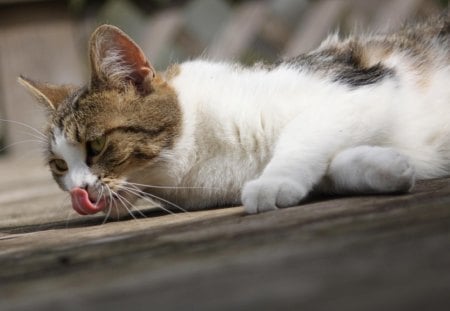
xmin=241 ymin=123 xmax=337 ymax=214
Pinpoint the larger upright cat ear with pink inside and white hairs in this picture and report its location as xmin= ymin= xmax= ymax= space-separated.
xmin=90 ymin=25 xmax=155 ymax=93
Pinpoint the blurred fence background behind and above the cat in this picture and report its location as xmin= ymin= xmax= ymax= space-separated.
xmin=0 ymin=0 xmax=448 ymax=156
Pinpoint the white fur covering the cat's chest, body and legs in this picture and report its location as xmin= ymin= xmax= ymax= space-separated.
xmin=140 ymin=55 xmax=450 ymax=213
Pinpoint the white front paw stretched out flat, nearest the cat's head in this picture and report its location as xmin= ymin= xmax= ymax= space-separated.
xmin=242 ymin=177 xmax=307 ymax=214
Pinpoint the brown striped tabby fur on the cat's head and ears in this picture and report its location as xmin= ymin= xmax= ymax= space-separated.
xmin=19 ymin=24 xmax=182 ymax=208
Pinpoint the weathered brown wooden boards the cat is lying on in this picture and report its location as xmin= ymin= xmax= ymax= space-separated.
xmin=0 ymin=158 xmax=450 ymax=311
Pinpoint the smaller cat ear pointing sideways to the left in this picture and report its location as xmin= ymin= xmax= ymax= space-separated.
xmin=17 ymin=76 xmax=74 ymax=111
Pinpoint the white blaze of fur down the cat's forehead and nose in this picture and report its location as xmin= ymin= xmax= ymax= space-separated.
xmin=52 ymin=129 xmax=97 ymax=191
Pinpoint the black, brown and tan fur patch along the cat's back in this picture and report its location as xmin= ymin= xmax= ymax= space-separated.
xmin=287 ymin=12 xmax=450 ymax=88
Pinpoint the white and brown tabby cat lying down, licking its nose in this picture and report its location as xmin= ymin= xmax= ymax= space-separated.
xmin=19 ymin=13 xmax=450 ymax=217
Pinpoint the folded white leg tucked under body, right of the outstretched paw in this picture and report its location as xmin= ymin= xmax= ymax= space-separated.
xmin=326 ymin=146 xmax=415 ymax=194
